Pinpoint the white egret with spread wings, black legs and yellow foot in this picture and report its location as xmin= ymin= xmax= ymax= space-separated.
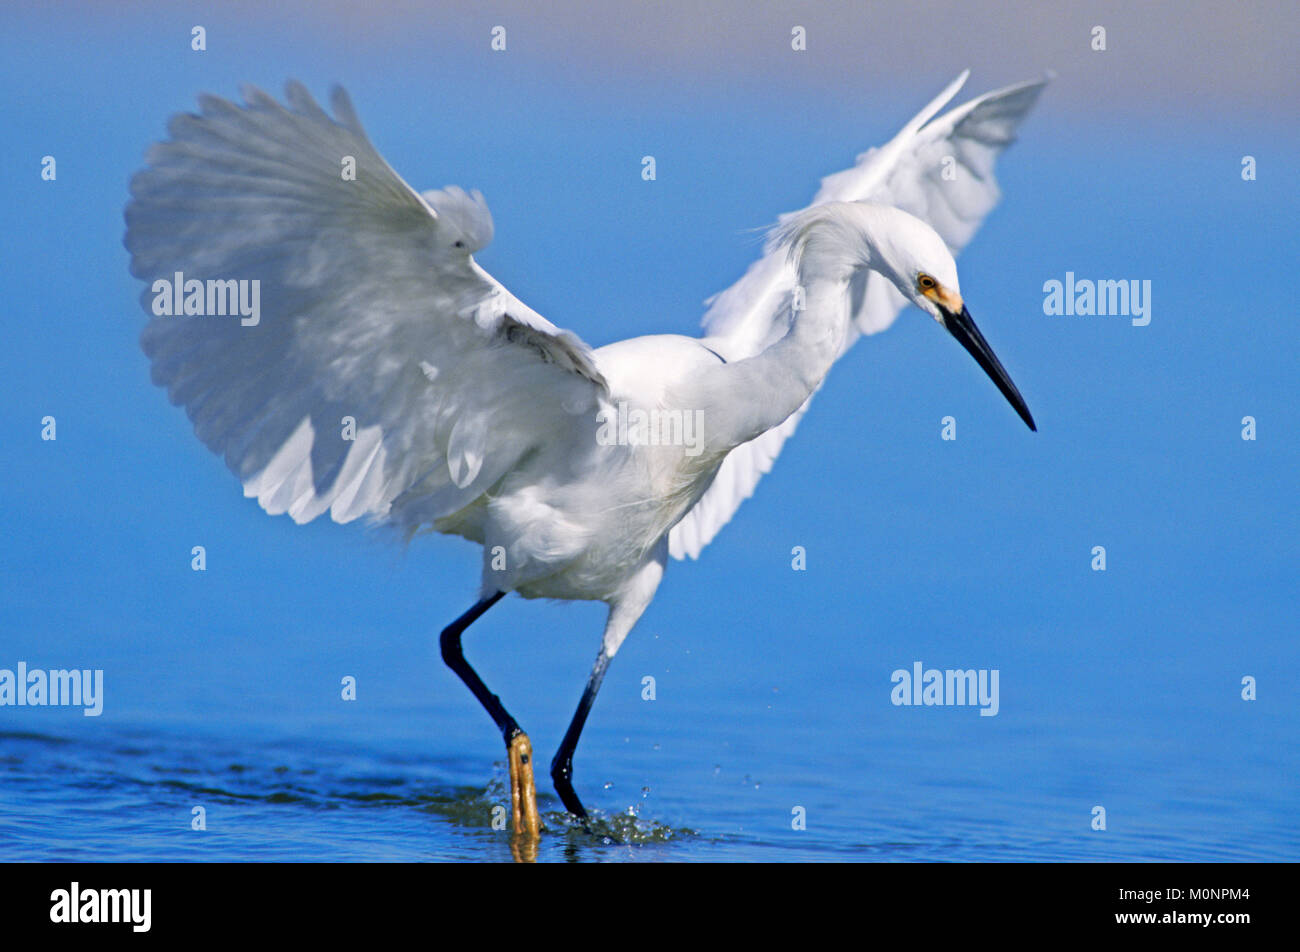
xmin=125 ymin=73 xmax=1045 ymax=836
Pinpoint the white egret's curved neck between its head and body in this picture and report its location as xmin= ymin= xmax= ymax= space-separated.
xmin=699 ymin=269 xmax=852 ymax=454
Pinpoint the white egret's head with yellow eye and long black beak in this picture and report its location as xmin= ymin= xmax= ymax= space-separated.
xmin=776 ymin=202 xmax=1037 ymax=430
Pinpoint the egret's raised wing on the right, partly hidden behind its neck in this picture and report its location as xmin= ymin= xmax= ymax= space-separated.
xmin=668 ymin=70 xmax=1048 ymax=559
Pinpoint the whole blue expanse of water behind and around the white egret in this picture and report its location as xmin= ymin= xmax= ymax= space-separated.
xmin=0 ymin=5 xmax=1300 ymax=860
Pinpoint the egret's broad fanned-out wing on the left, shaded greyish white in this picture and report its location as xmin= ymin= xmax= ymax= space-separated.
xmin=125 ymin=83 xmax=607 ymax=529
